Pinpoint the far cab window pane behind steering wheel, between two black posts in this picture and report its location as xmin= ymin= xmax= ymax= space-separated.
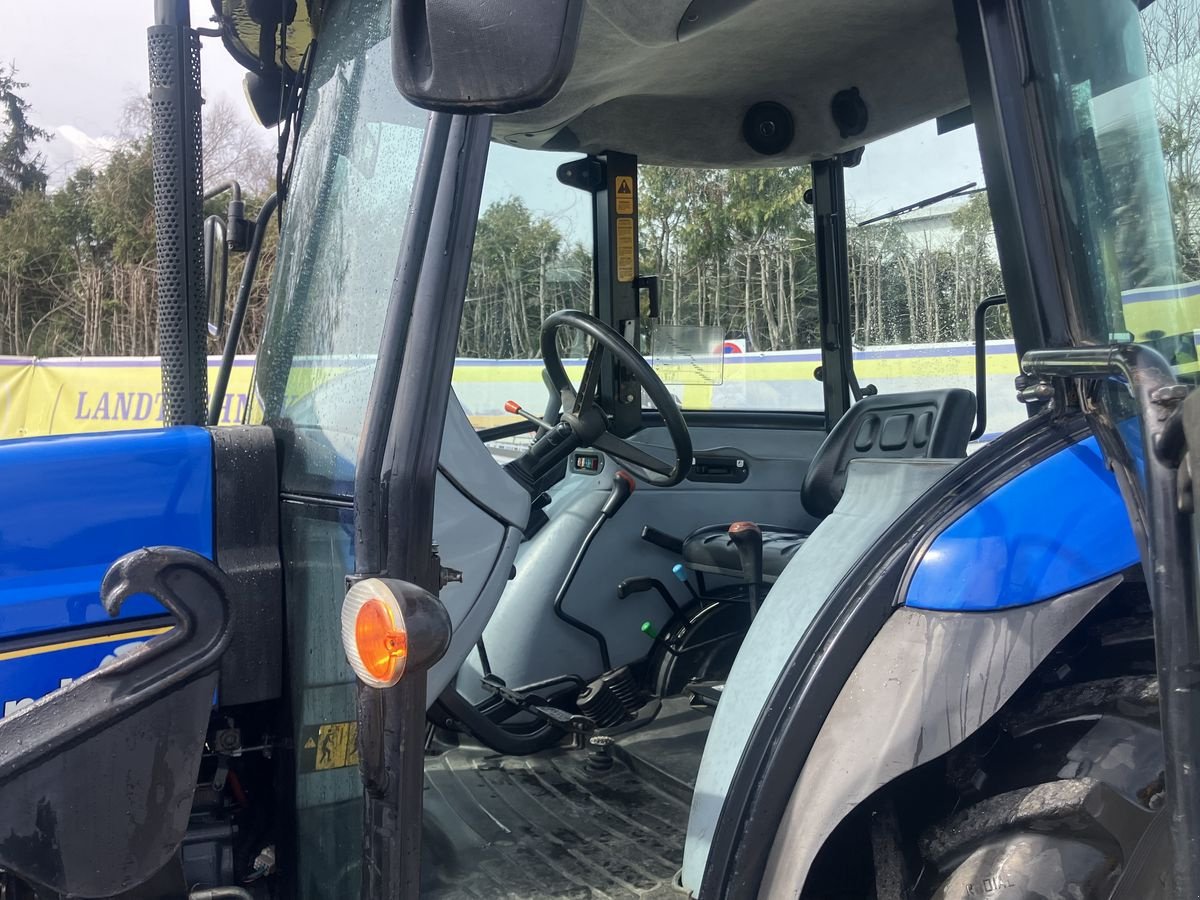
xmin=638 ymin=166 xmax=823 ymax=410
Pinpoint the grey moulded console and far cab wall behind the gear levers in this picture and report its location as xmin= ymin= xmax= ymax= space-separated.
xmin=458 ymin=428 xmax=824 ymax=702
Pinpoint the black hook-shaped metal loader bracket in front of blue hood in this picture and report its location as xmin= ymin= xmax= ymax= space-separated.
xmin=0 ymin=547 xmax=233 ymax=896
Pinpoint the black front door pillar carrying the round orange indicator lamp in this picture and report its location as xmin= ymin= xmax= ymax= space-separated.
xmin=354 ymin=115 xmax=491 ymax=900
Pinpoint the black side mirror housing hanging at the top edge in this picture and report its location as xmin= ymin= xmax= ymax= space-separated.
xmin=391 ymin=0 xmax=584 ymax=113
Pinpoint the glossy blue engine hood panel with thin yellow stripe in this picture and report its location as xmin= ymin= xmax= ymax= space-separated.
xmin=0 ymin=427 xmax=212 ymax=720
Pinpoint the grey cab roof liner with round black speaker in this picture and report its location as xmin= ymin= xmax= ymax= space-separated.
xmin=493 ymin=0 xmax=967 ymax=167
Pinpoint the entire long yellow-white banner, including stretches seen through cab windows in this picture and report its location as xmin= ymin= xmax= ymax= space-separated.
xmin=0 ymin=341 xmax=1026 ymax=439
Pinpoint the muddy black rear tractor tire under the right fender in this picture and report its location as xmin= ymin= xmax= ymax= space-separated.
xmin=914 ymin=677 xmax=1166 ymax=900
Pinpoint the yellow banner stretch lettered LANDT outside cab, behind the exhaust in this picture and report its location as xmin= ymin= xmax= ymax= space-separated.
xmin=0 ymin=356 xmax=253 ymax=439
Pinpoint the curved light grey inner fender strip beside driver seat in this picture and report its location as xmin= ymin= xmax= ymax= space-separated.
xmin=683 ymin=460 xmax=958 ymax=892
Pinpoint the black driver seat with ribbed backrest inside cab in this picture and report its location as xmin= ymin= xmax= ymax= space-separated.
xmin=683 ymin=388 xmax=976 ymax=584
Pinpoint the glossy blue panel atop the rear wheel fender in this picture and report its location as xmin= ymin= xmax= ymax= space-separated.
xmin=905 ymin=438 xmax=1140 ymax=612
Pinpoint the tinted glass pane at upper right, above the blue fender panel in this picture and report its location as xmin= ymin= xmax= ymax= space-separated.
xmin=1027 ymin=0 xmax=1200 ymax=377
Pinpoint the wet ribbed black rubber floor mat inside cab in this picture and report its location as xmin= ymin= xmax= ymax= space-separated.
xmin=421 ymin=748 xmax=688 ymax=900
